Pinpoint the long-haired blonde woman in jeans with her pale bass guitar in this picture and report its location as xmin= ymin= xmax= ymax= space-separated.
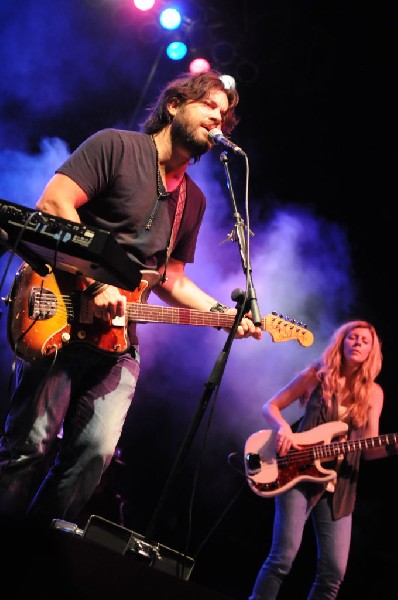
xmin=245 ymin=320 xmax=398 ymax=600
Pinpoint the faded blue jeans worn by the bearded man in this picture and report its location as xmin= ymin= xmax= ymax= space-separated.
xmin=0 ymin=345 xmax=139 ymax=524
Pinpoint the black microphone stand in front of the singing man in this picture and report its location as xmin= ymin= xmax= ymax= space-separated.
xmin=145 ymin=146 xmax=261 ymax=542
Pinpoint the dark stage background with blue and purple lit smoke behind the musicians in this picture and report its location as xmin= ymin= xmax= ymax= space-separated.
xmin=0 ymin=0 xmax=398 ymax=600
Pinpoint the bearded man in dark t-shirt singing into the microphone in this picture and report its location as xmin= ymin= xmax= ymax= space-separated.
xmin=0 ymin=71 xmax=262 ymax=525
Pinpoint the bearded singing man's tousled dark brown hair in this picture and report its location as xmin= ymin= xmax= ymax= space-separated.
xmin=141 ymin=70 xmax=239 ymax=135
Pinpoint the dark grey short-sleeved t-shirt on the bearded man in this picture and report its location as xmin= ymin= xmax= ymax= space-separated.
xmin=56 ymin=129 xmax=206 ymax=343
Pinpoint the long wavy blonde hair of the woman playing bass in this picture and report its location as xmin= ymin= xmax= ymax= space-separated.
xmin=317 ymin=320 xmax=383 ymax=427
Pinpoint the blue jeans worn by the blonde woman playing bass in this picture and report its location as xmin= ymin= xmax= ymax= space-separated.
xmin=249 ymin=484 xmax=352 ymax=600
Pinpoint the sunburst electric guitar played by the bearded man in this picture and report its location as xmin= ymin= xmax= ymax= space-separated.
xmin=6 ymin=263 xmax=314 ymax=362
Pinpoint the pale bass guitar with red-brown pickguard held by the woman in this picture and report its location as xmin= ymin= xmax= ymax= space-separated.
xmin=245 ymin=421 xmax=398 ymax=498
